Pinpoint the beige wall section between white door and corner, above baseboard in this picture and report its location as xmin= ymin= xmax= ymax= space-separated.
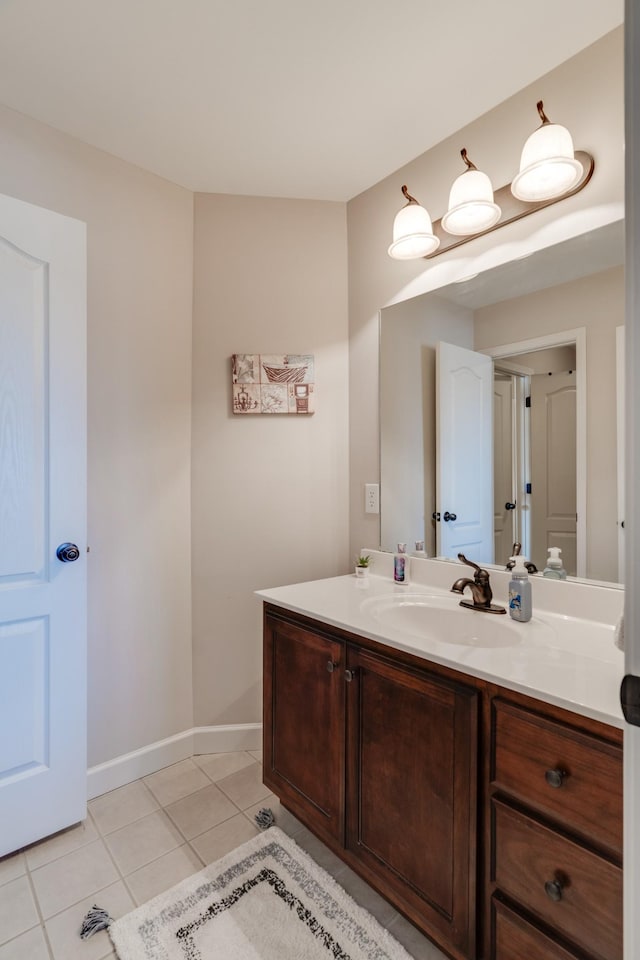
xmin=0 ymin=108 xmax=193 ymax=765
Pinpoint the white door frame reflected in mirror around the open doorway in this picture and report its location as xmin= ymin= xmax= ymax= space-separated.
xmin=478 ymin=327 xmax=587 ymax=577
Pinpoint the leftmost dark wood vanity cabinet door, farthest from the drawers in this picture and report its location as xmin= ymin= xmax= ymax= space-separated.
xmin=264 ymin=616 xmax=345 ymax=843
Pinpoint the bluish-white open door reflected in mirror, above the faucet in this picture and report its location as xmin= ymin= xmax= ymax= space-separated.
xmin=436 ymin=342 xmax=493 ymax=563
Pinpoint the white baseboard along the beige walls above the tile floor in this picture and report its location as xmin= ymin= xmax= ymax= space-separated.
xmin=87 ymin=723 xmax=262 ymax=800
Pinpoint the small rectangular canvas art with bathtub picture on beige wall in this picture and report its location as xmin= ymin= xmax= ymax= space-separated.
xmin=231 ymin=353 xmax=315 ymax=415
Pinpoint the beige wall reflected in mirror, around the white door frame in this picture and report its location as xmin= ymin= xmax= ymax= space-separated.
xmin=474 ymin=267 xmax=624 ymax=581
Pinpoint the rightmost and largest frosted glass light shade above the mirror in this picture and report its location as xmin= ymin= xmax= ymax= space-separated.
xmin=511 ymin=123 xmax=582 ymax=202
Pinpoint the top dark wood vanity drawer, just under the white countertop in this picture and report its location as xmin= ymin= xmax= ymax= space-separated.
xmin=492 ymin=699 xmax=622 ymax=858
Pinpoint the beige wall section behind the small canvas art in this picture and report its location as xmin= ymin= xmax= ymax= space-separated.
xmin=192 ymin=194 xmax=350 ymax=725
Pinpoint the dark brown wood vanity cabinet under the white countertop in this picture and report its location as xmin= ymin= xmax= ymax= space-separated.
xmin=264 ymin=604 xmax=622 ymax=960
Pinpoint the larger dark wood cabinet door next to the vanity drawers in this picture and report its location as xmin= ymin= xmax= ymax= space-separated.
xmin=347 ymin=649 xmax=478 ymax=957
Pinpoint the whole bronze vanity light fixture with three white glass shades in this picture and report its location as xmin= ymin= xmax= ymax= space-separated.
xmin=388 ymin=100 xmax=594 ymax=260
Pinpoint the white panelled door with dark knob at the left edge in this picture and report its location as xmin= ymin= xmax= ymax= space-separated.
xmin=0 ymin=196 xmax=87 ymax=856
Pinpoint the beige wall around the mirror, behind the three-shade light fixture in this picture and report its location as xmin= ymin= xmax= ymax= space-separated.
xmin=347 ymin=29 xmax=624 ymax=564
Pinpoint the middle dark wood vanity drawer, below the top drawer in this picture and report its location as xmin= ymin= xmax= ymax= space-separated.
xmin=492 ymin=799 xmax=622 ymax=960
